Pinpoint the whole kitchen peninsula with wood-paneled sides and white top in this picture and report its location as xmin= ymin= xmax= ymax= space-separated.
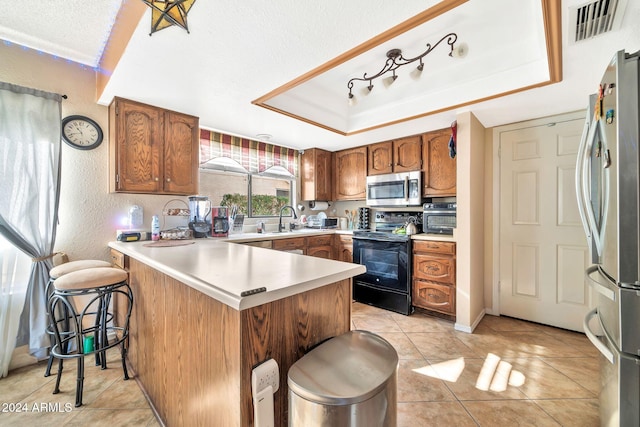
xmin=109 ymin=239 xmax=365 ymax=427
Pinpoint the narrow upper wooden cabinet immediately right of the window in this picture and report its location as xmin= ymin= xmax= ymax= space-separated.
xmin=300 ymin=148 xmax=333 ymax=201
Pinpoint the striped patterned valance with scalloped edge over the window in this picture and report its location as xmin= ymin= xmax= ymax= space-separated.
xmin=200 ymin=129 xmax=299 ymax=177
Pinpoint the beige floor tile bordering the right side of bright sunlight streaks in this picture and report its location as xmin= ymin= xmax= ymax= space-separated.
xmin=506 ymin=358 xmax=597 ymax=399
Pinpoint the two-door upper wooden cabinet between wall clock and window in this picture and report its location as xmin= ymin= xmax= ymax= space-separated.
xmin=109 ymin=98 xmax=199 ymax=195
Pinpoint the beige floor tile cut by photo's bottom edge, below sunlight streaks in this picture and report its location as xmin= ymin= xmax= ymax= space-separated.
xmin=462 ymin=400 xmax=560 ymax=427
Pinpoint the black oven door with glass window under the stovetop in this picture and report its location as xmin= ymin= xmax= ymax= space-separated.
xmin=353 ymin=236 xmax=411 ymax=293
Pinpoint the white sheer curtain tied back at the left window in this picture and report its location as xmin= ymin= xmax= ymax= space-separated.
xmin=0 ymin=82 xmax=62 ymax=377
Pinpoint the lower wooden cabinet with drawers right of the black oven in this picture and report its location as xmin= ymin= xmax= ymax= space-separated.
xmin=412 ymin=241 xmax=456 ymax=316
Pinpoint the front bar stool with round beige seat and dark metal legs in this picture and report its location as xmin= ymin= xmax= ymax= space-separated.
xmin=48 ymin=267 xmax=133 ymax=407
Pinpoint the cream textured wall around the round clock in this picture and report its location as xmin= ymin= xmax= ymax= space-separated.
xmin=0 ymin=43 xmax=186 ymax=261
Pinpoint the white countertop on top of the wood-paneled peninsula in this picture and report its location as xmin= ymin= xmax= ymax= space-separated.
xmin=109 ymin=237 xmax=366 ymax=310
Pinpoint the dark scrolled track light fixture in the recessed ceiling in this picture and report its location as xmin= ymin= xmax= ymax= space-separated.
xmin=347 ymin=33 xmax=458 ymax=105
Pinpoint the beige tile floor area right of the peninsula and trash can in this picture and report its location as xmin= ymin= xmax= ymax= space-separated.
xmin=352 ymin=303 xmax=600 ymax=427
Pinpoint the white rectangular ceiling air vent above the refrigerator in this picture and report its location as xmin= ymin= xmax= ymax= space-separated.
xmin=567 ymin=0 xmax=627 ymax=43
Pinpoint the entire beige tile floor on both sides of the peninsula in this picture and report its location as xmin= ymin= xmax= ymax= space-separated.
xmin=0 ymin=303 xmax=600 ymax=427
